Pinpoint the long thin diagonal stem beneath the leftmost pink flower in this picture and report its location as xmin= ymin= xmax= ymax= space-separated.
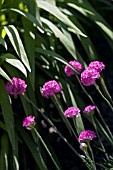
xmin=23 ymin=94 xmax=89 ymax=167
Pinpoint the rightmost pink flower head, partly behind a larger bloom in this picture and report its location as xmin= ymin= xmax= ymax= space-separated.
xmin=89 ymin=61 xmax=105 ymax=72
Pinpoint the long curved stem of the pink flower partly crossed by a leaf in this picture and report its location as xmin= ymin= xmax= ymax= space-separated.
xmin=75 ymin=74 xmax=113 ymax=140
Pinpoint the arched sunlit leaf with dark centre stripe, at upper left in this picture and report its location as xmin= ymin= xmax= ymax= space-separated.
xmin=4 ymin=25 xmax=31 ymax=72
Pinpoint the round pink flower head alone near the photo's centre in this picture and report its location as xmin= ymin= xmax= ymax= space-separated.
xmin=42 ymin=80 xmax=62 ymax=98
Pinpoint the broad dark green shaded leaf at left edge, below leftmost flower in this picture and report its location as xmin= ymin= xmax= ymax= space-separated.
xmin=0 ymin=79 xmax=15 ymax=149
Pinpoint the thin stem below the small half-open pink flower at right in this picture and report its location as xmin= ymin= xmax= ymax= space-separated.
xmin=91 ymin=115 xmax=109 ymax=161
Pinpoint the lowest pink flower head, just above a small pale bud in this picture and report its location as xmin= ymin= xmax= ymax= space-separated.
xmin=78 ymin=130 xmax=96 ymax=142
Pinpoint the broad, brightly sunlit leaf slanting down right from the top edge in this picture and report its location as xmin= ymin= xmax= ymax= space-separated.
xmin=36 ymin=0 xmax=86 ymax=37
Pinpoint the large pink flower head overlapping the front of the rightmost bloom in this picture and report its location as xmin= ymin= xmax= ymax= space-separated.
xmin=81 ymin=68 xmax=100 ymax=86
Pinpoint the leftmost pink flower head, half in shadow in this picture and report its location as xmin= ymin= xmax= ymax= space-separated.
xmin=6 ymin=77 xmax=27 ymax=96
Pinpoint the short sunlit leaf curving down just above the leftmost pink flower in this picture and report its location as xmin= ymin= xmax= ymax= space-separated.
xmin=0 ymin=54 xmax=27 ymax=77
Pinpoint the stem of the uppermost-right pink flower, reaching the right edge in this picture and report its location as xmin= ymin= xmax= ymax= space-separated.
xmin=99 ymin=77 xmax=113 ymax=104
